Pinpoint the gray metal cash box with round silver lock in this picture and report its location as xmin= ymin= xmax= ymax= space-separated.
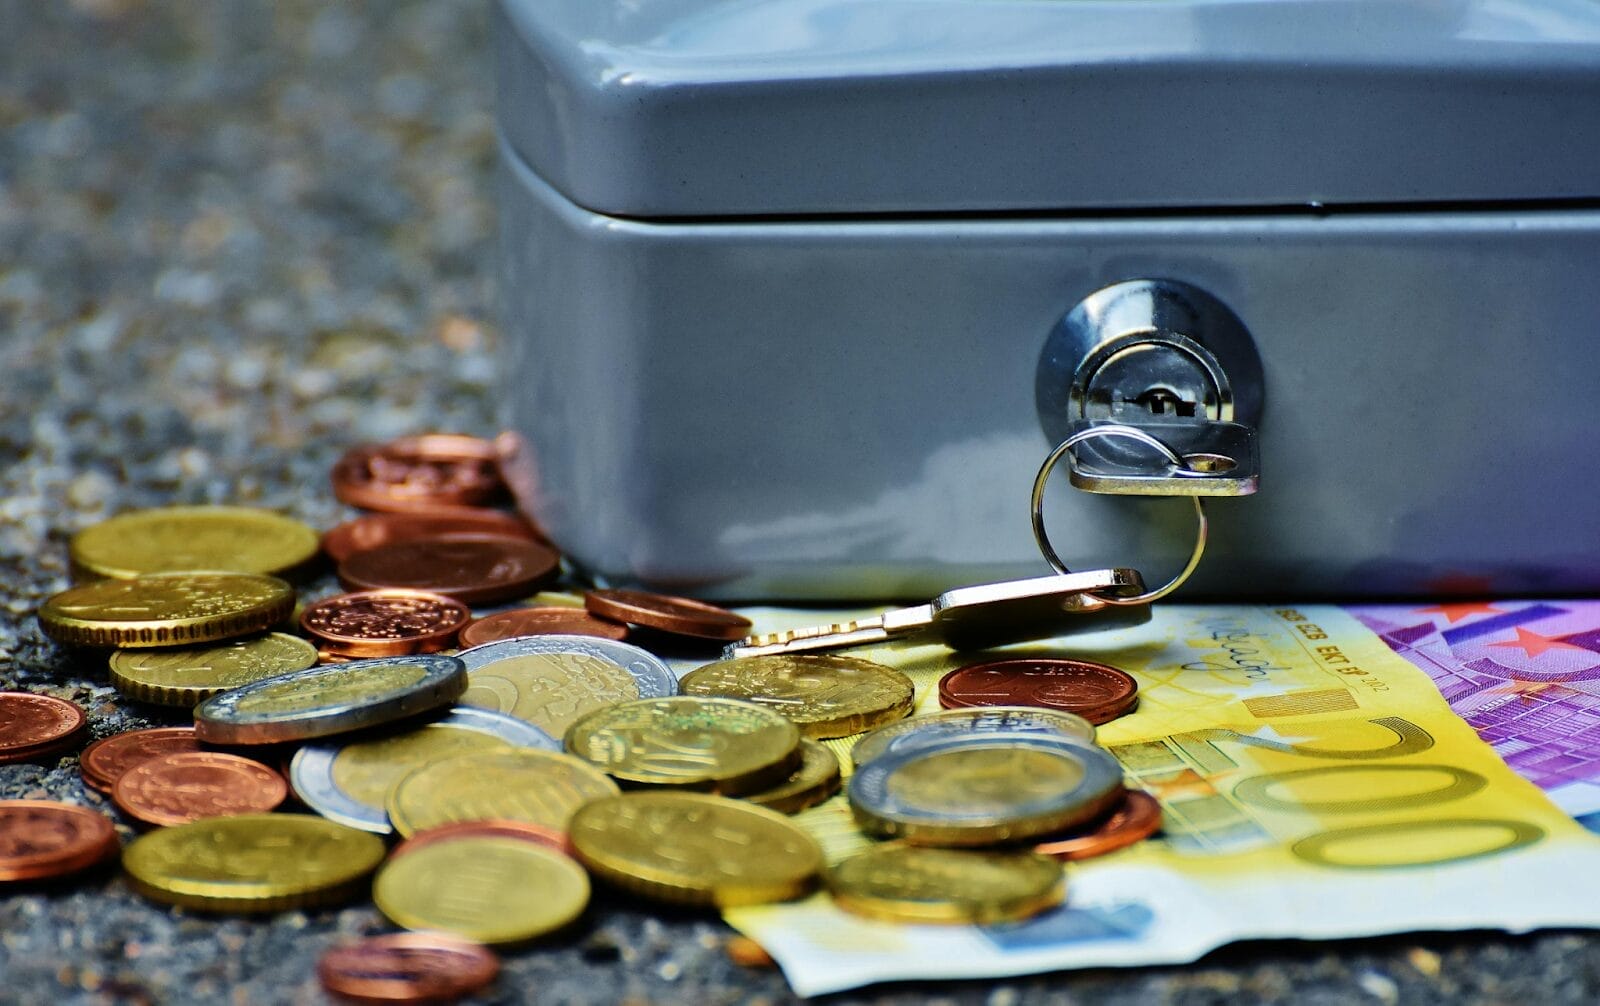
xmin=498 ymin=0 xmax=1600 ymax=600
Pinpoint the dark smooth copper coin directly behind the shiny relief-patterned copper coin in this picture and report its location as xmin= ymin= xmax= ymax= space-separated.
xmin=339 ymin=534 xmax=562 ymax=605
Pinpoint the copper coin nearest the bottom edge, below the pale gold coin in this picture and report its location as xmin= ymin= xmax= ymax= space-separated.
xmin=317 ymin=932 xmax=499 ymax=1003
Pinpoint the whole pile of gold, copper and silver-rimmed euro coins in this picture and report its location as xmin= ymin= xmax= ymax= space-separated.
xmin=0 ymin=435 xmax=1160 ymax=998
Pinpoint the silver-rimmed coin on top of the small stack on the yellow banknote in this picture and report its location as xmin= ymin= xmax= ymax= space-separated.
xmin=848 ymin=734 xmax=1123 ymax=846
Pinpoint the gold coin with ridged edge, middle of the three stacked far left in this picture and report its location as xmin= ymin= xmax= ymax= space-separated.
xmin=38 ymin=573 xmax=294 ymax=648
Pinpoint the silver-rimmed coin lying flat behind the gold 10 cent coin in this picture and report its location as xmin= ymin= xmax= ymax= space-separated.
xmin=456 ymin=635 xmax=678 ymax=737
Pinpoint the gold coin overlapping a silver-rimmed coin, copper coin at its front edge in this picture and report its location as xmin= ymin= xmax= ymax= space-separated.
xmin=386 ymin=749 xmax=621 ymax=838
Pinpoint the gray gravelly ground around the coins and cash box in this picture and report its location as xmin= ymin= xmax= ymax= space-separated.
xmin=0 ymin=0 xmax=1600 ymax=1006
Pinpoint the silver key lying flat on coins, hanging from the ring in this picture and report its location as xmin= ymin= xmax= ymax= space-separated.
xmin=723 ymin=569 xmax=1150 ymax=659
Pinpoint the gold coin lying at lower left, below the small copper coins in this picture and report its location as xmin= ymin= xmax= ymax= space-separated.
xmin=122 ymin=814 xmax=384 ymax=912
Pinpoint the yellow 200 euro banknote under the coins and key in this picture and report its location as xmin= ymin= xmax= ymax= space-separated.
xmin=725 ymin=605 xmax=1600 ymax=995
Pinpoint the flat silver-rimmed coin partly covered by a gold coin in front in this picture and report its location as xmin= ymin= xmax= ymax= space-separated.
xmin=290 ymin=705 xmax=562 ymax=835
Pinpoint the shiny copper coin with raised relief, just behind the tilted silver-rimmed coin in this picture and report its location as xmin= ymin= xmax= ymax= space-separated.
xmin=301 ymin=589 xmax=472 ymax=657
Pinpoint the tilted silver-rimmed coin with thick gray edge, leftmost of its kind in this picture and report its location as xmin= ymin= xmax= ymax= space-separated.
xmin=195 ymin=653 xmax=467 ymax=744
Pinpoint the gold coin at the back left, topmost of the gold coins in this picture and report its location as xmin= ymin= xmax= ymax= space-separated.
xmin=70 ymin=507 xmax=318 ymax=579
